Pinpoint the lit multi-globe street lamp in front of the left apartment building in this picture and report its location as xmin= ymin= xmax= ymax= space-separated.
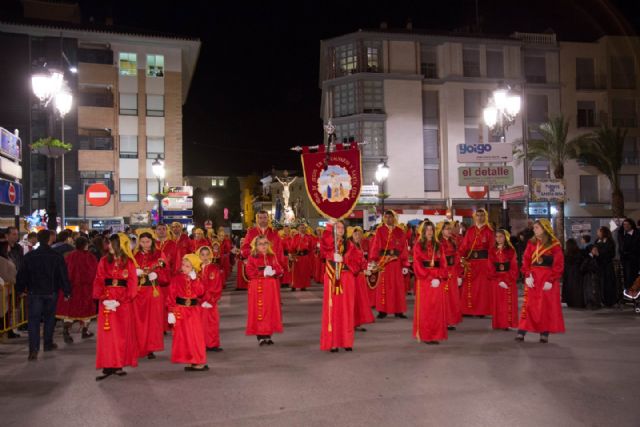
xmin=31 ymin=70 xmax=73 ymax=230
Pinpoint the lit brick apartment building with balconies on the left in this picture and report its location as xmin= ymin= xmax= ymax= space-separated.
xmin=0 ymin=8 xmax=200 ymax=224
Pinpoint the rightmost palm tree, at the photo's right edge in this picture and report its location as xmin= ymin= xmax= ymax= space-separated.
xmin=575 ymin=124 xmax=627 ymax=218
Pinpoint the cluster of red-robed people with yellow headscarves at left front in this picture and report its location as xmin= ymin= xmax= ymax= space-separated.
xmin=93 ymin=223 xmax=231 ymax=380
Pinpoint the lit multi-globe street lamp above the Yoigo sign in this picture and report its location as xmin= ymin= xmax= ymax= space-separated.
xmin=482 ymin=85 xmax=521 ymax=229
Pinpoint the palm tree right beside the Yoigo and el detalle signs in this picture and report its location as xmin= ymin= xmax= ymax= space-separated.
xmin=514 ymin=114 xmax=588 ymax=244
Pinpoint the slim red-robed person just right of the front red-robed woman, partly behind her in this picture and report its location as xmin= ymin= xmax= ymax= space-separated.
xmin=436 ymin=221 xmax=462 ymax=331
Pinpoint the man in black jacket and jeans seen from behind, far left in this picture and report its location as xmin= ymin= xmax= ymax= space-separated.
xmin=16 ymin=230 xmax=71 ymax=360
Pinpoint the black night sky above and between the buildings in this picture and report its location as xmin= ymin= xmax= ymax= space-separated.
xmin=5 ymin=0 xmax=640 ymax=175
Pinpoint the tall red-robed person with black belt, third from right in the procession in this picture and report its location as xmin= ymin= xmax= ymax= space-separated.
xmin=458 ymin=209 xmax=494 ymax=316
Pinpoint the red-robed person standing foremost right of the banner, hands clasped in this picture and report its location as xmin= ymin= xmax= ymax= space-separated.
xmin=413 ymin=220 xmax=448 ymax=344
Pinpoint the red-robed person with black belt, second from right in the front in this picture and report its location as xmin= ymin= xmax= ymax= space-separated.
xmin=488 ymin=229 xmax=518 ymax=331
